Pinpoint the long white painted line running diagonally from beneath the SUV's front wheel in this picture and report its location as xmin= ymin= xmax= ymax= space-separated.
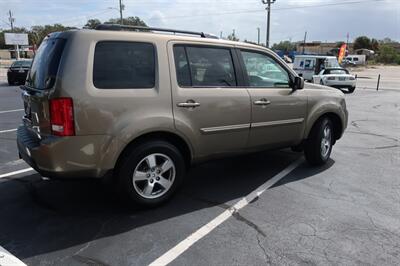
xmin=150 ymin=159 xmax=303 ymax=266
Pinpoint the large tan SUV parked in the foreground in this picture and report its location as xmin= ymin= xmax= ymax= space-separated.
xmin=17 ymin=25 xmax=348 ymax=206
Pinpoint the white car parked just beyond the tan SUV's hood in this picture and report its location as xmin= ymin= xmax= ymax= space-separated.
xmin=313 ymin=68 xmax=356 ymax=93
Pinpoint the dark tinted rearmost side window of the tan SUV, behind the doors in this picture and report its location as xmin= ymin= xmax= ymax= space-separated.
xmin=93 ymin=41 xmax=155 ymax=89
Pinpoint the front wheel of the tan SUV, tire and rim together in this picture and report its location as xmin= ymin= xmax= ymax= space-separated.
xmin=304 ymin=118 xmax=334 ymax=165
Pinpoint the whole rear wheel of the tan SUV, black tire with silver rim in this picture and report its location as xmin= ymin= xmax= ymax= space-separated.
xmin=117 ymin=140 xmax=185 ymax=207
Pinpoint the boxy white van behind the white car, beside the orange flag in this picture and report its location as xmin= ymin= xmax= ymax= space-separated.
xmin=293 ymin=55 xmax=340 ymax=81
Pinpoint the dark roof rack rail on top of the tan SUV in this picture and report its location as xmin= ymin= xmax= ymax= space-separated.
xmin=95 ymin=24 xmax=219 ymax=39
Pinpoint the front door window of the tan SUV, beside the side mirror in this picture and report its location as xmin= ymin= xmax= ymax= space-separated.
xmin=241 ymin=51 xmax=290 ymax=88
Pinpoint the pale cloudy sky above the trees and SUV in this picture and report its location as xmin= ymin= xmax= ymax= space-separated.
xmin=0 ymin=0 xmax=400 ymax=43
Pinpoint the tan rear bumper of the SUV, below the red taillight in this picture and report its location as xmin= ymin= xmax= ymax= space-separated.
xmin=17 ymin=126 xmax=116 ymax=178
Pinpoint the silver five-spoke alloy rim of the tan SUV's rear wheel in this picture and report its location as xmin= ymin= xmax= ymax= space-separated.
xmin=132 ymin=153 xmax=176 ymax=199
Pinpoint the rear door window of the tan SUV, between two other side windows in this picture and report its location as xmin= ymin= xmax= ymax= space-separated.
xmin=174 ymin=46 xmax=237 ymax=87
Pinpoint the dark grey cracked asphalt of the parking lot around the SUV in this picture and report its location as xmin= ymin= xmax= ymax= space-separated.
xmin=0 ymin=68 xmax=400 ymax=265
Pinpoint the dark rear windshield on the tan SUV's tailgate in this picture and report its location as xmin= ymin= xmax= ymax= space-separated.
xmin=27 ymin=38 xmax=65 ymax=90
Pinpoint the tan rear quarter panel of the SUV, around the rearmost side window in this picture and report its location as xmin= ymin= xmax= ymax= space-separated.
xmin=53 ymin=31 xmax=174 ymax=169
